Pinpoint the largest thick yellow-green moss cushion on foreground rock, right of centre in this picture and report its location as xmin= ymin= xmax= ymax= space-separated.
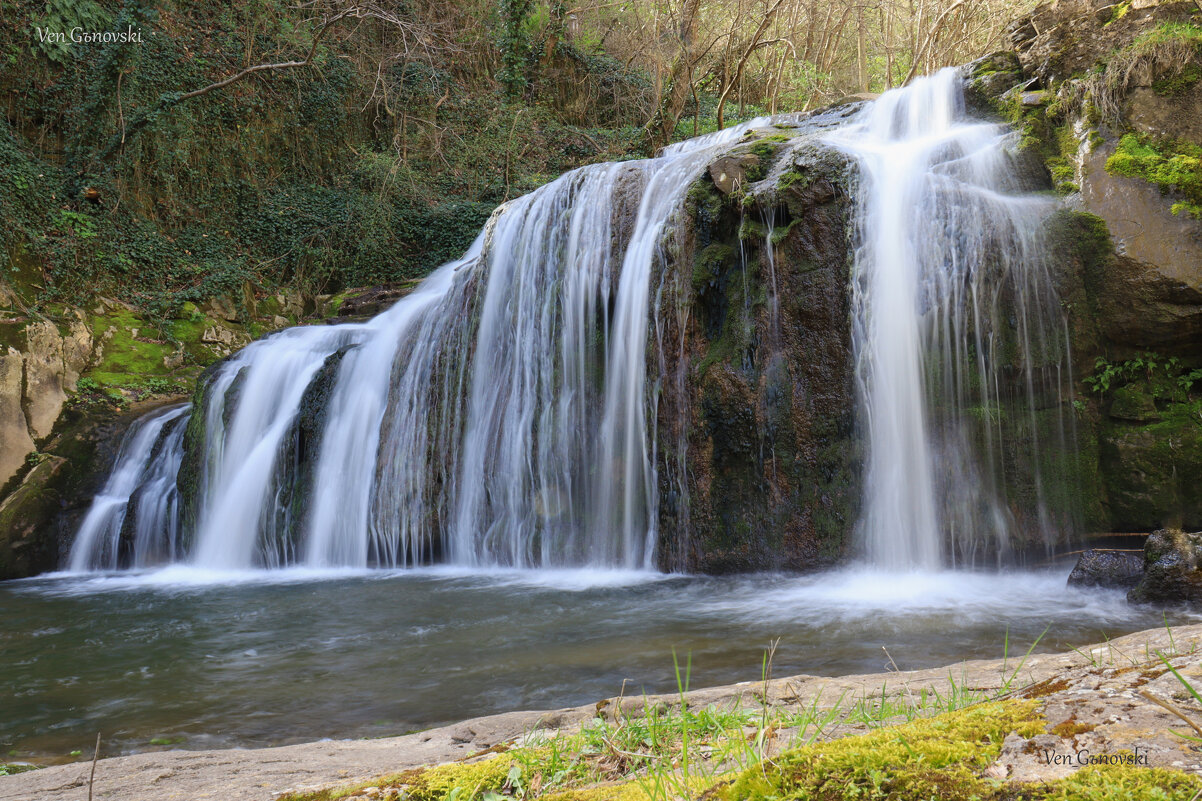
xmin=715 ymin=701 xmax=1045 ymax=801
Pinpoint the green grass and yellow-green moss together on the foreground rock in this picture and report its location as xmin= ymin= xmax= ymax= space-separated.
xmin=281 ymin=653 xmax=1202 ymax=801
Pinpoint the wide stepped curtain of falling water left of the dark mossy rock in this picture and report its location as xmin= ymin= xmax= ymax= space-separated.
xmin=70 ymin=120 xmax=764 ymax=569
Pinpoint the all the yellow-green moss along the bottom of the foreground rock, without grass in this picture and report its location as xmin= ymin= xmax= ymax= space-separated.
xmin=279 ymin=700 xmax=1202 ymax=801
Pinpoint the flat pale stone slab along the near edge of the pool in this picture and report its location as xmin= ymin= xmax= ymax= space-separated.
xmin=0 ymin=624 xmax=1202 ymax=801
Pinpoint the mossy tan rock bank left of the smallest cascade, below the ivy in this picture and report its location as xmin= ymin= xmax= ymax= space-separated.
xmin=0 ymin=281 xmax=328 ymax=580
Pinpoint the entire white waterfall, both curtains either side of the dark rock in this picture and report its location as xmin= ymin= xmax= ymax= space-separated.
xmin=70 ymin=70 xmax=1071 ymax=570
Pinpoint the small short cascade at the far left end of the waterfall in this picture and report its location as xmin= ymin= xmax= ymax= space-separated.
xmin=69 ymin=403 xmax=191 ymax=571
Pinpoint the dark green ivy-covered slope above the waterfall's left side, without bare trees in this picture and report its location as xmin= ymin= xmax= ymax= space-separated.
xmin=0 ymin=0 xmax=641 ymax=316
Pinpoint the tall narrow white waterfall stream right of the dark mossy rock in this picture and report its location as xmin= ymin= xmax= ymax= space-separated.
xmin=829 ymin=69 xmax=1071 ymax=570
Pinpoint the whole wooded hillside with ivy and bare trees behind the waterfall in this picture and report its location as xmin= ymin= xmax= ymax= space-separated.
xmin=0 ymin=0 xmax=1033 ymax=320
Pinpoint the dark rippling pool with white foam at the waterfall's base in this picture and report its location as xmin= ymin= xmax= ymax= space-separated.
xmin=0 ymin=566 xmax=1200 ymax=761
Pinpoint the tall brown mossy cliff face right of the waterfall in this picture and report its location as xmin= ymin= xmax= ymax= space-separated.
xmin=977 ymin=0 xmax=1202 ymax=532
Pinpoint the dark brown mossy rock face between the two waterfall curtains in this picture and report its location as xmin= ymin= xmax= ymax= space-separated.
xmin=657 ymin=134 xmax=859 ymax=572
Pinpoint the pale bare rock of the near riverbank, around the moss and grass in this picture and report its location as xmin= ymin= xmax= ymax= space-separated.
xmin=0 ymin=624 xmax=1202 ymax=801
